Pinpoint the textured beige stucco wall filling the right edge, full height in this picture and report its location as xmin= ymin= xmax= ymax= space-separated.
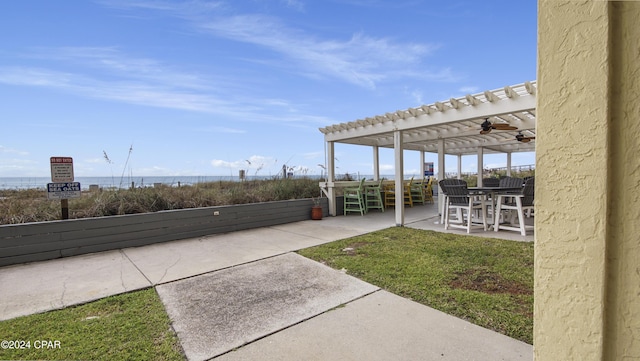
xmin=534 ymin=0 xmax=640 ymax=360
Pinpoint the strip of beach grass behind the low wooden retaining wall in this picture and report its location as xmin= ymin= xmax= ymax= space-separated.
xmin=0 ymin=178 xmax=320 ymax=225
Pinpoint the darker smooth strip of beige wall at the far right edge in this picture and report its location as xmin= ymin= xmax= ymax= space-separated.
xmin=604 ymin=1 xmax=640 ymax=360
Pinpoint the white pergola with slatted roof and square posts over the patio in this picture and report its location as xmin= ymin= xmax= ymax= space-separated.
xmin=320 ymin=81 xmax=537 ymax=226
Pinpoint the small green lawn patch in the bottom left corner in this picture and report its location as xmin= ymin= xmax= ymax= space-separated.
xmin=0 ymin=288 xmax=185 ymax=361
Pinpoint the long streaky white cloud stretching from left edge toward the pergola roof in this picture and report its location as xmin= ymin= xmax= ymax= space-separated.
xmin=0 ymin=43 xmax=336 ymax=126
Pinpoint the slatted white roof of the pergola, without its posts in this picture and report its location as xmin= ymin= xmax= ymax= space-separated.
xmin=320 ymin=81 xmax=536 ymax=155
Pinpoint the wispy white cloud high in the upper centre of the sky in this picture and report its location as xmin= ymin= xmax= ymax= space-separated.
xmin=200 ymin=15 xmax=440 ymax=88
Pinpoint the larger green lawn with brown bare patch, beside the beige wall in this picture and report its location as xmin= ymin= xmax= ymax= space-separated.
xmin=299 ymin=227 xmax=533 ymax=344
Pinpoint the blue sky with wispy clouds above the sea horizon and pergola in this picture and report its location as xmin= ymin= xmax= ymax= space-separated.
xmin=0 ymin=0 xmax=537 ymax=177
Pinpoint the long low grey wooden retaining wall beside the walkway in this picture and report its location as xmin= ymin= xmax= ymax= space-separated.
xmin=0 ymin=198 xmax=330 ymax=266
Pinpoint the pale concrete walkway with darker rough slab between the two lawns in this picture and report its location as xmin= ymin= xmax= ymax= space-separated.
xmin=0 ymin=202 xmax=533 ymax=360
